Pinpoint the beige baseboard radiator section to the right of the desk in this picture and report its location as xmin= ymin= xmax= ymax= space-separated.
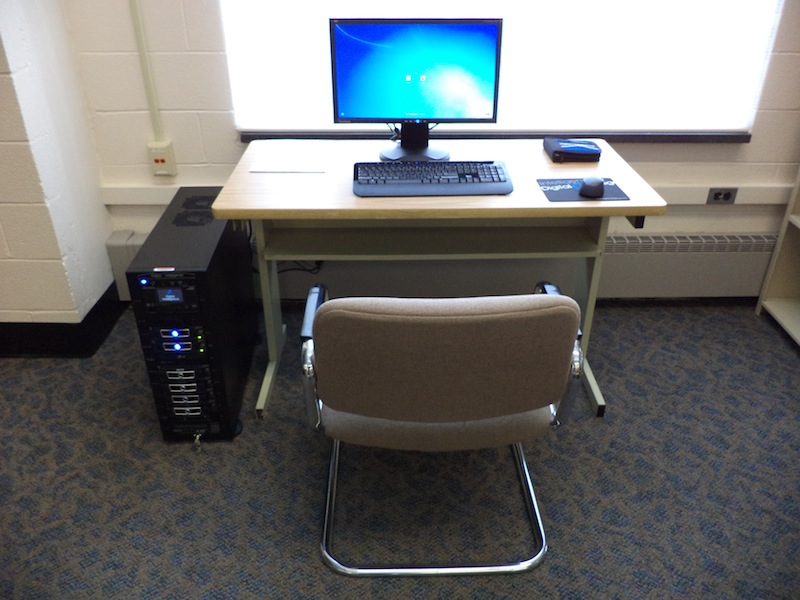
xmin=598 ymin=234 xmax=777 ymax=298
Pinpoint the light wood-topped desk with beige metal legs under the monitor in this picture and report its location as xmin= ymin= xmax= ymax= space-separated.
xmin=212 ymin=140 xmax=666 ymax=417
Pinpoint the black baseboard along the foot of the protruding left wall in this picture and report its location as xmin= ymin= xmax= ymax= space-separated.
xmin=0 ymin=284 xmax=128 ymax=358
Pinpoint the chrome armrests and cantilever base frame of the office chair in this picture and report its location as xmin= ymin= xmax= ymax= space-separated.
xmin=301 ymin=286 xmax=583 ymax=576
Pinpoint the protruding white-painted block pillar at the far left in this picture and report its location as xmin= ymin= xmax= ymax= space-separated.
xmin=0 ymin=0 xmax=113 ymax=323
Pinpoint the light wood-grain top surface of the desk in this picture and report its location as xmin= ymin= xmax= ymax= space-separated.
xmin=212 ymin=140 xmax=666 ymax=220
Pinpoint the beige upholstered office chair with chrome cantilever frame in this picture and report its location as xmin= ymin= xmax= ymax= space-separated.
xmin=301 ymin=285 xmax=583 ymax=576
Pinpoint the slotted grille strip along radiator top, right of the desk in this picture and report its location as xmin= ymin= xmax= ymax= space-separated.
xmin=605 ymin=234 xmax=778 ymax=254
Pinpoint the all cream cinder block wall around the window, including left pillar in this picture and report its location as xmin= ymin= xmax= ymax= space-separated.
xmin=0 ymin=0 xmax=800 ymax=322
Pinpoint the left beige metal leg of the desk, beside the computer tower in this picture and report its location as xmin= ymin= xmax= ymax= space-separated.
xmin=255 ymin=223 xmax=286 ymax=419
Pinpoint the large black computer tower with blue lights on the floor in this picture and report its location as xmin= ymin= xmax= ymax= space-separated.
xmin=126 ymin=187 xmax=257 ymax=441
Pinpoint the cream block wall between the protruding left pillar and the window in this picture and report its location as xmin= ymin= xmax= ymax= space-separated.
xmin=61 ymin=0 xmax=244 ymax=232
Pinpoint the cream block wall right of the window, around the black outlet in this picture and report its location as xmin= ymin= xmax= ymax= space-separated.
xmin=614 ymin=0 xmax=800 ymax=239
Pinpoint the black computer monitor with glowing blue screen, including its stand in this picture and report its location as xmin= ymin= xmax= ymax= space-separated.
xmin=330 ymin=19 xmax=502 ymax=160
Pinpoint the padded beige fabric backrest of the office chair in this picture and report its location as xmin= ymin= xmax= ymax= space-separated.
xmin=314 ymin=294 xmax=580 ymax=423
